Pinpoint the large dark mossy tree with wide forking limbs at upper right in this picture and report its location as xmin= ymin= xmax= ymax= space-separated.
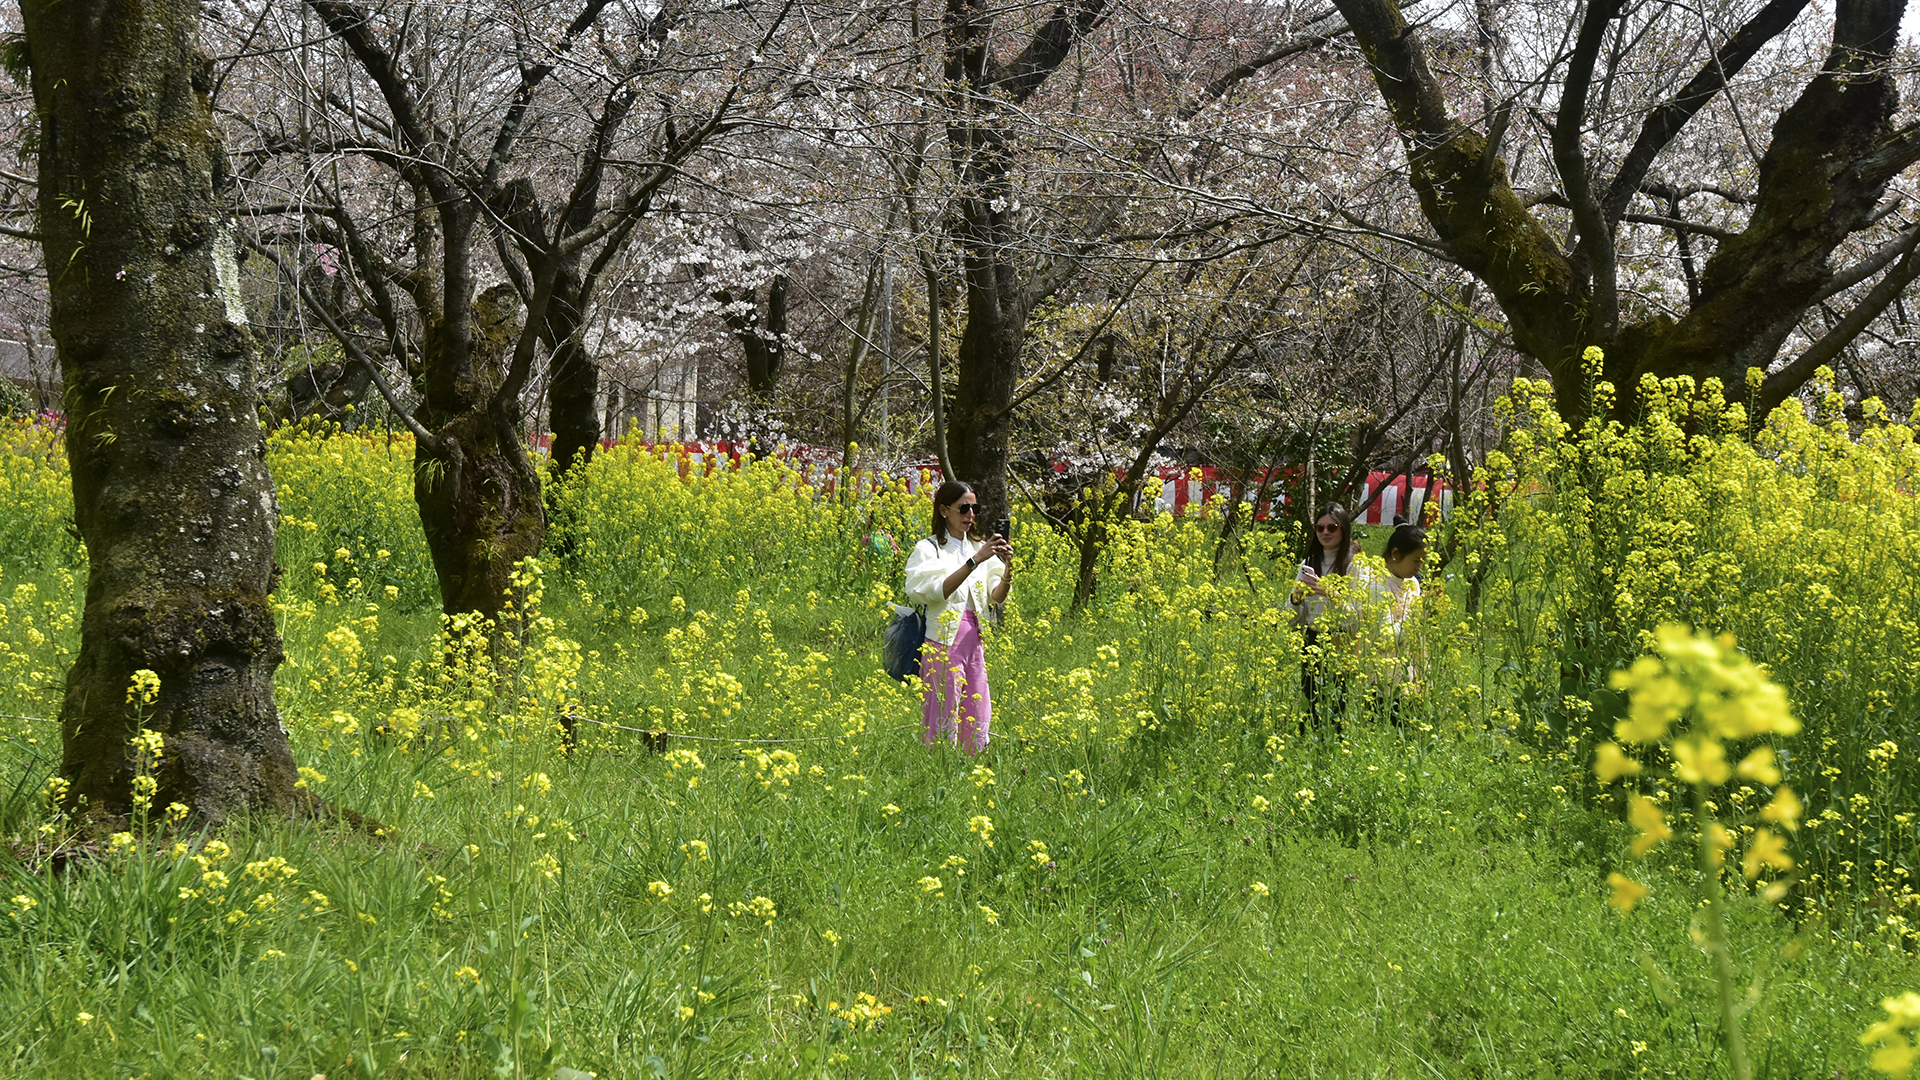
xmin=1334 ymin=0 xmax=1920 ymax=417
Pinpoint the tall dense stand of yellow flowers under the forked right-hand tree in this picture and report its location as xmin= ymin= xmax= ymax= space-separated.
xmin=1442 ymin=357 xmax=1920 ymax=924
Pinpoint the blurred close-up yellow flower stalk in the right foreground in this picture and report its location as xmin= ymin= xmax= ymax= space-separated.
xmin=1594 ymin=623 xmax=1801 ymax=1080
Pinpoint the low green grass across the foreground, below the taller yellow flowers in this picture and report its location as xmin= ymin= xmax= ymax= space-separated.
xmin=0 ymin=580 xmax=1916 ymax=1078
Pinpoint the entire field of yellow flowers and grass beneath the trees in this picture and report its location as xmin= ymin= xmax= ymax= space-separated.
xmin=0 ymin=374 xmax=1920 ymax=1080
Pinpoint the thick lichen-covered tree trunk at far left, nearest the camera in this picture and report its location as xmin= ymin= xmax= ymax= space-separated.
xmin=21 ymin=0 xmax=309 ymax=822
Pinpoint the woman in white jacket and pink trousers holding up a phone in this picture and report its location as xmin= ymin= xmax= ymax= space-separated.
xmin=906 ymin=480 xmax=1014 ymax=753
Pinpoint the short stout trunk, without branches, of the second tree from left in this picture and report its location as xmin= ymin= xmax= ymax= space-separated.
xmin=413 ymin=284 xmax=547 ymax=619
